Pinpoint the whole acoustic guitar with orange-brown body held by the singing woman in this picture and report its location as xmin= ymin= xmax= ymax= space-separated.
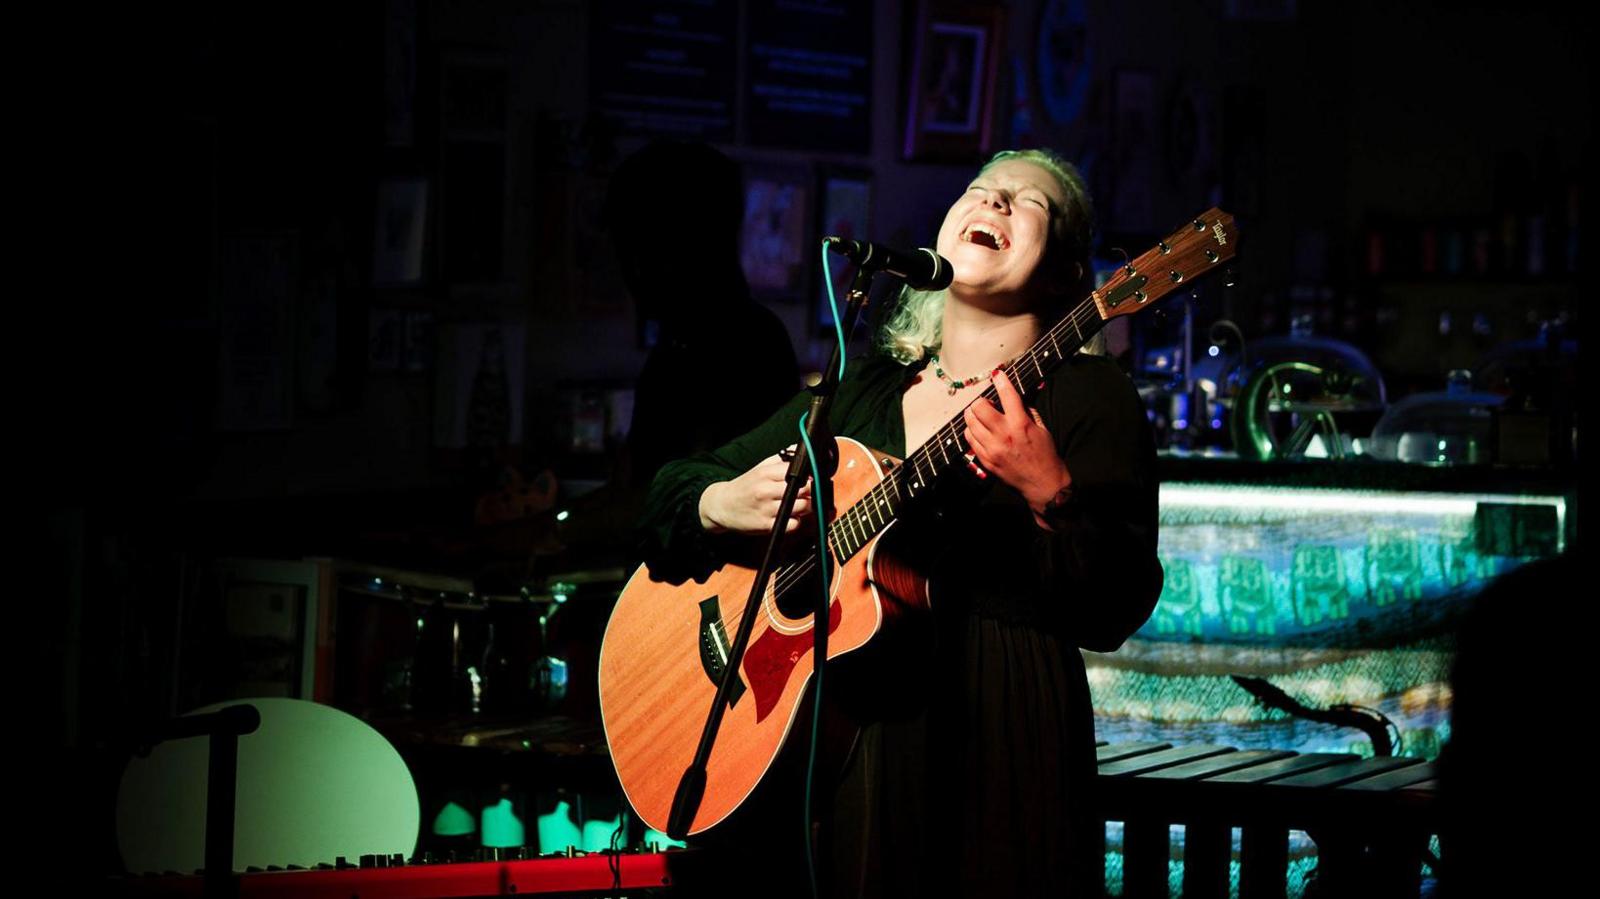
xmin=600 ymin=208 xmax=1237 ymax=833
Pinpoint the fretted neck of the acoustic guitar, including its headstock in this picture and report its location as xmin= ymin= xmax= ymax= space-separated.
xmin=827 ymin=208 xmax=1238 ymax=560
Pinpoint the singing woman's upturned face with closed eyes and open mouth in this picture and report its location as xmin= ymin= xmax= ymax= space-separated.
xmin=939 ymin=158 xmax=1067 ymax=301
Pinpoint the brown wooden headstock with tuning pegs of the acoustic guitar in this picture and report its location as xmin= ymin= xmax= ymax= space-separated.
xmin=1090 ymin=206 xmax=1238 ymax=322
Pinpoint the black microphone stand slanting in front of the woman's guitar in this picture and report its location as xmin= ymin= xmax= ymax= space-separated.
xmin=667 ymin=266 xmax=872 ymax=857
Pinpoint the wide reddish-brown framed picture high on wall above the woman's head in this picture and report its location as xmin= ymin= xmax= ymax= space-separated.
xmin=902 ymin=0 xmax=1003 ymax=162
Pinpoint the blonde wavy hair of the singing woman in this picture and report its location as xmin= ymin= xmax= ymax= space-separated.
xmin=877 ymin=149 xmax=1106 ymax=365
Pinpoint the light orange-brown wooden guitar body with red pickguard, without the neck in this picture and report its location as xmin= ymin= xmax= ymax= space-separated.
xmin=600 ymin=438 xmax=928 ymax=833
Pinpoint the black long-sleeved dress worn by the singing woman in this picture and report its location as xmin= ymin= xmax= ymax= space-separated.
xmin=630 ymin=355 xmax=1162 ymax=896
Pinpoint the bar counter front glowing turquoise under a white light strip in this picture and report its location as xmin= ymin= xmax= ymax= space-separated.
xmin=1085 ymin=456 xmax=1576 ymax=758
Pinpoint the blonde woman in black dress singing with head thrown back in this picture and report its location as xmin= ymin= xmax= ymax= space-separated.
xmin=643 ymin=150 xmax=1162 ymax=896
